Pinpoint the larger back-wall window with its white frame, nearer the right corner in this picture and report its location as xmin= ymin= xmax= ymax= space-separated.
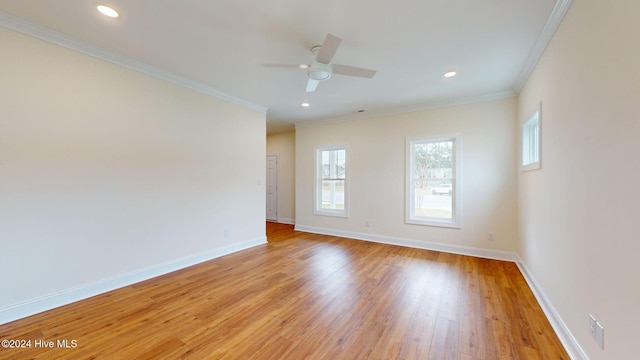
xmin=406 ymin=136 xmax=461 ymax=228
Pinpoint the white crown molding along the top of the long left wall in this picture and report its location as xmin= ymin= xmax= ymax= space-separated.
xmin=0 ymin=11 xmax=267 ymax=114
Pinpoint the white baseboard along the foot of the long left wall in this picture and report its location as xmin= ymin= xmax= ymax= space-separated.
xmin=0 ymin=236 xmax=267 ymax=325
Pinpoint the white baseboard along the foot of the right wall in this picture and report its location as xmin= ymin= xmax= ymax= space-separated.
xmin=516 ymin=256 xmax=589 ymax=360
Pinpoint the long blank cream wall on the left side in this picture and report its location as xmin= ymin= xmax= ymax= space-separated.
xmin=0 ymin=28 xmax=266 ymax=312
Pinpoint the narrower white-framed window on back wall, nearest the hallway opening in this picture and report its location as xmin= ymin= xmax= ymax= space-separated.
xmin=315 ymin=147 xmax=348 ymax=217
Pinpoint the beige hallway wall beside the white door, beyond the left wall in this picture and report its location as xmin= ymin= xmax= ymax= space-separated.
xmin=267 ymin=131 xmax=296 ymax=224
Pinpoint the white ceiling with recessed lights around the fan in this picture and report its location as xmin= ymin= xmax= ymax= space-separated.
xmin=0 ymin=0 xmax=570 ymax=133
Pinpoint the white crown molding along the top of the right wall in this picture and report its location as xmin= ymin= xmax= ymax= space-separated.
xmin=513 ymin=0 xmax=573 ymax=94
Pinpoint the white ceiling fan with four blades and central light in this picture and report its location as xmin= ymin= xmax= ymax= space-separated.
xmin=263 ymin=34 xmax=376 ymax=92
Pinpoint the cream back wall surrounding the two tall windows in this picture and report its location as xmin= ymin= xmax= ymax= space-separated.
xmin=296 ymin=98 xmax=517 ymax=251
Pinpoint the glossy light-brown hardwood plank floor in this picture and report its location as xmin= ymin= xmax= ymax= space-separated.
xmin=0 ymin=223 xmax=569 ymax=360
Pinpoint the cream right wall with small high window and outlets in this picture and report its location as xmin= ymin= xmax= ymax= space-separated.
xmin=519 ymin=0 xmax=640 ymax=360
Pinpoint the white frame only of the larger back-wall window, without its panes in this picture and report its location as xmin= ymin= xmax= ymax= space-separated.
xmin=405 ymin=134 xmax=462 ymax=229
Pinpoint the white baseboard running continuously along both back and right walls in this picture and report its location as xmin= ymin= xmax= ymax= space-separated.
xmin=295 ymin=225 xmax=589 ymax=360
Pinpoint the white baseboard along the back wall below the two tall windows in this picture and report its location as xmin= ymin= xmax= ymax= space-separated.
xmin=295 ymin=225 xmax=518 ymax=262
